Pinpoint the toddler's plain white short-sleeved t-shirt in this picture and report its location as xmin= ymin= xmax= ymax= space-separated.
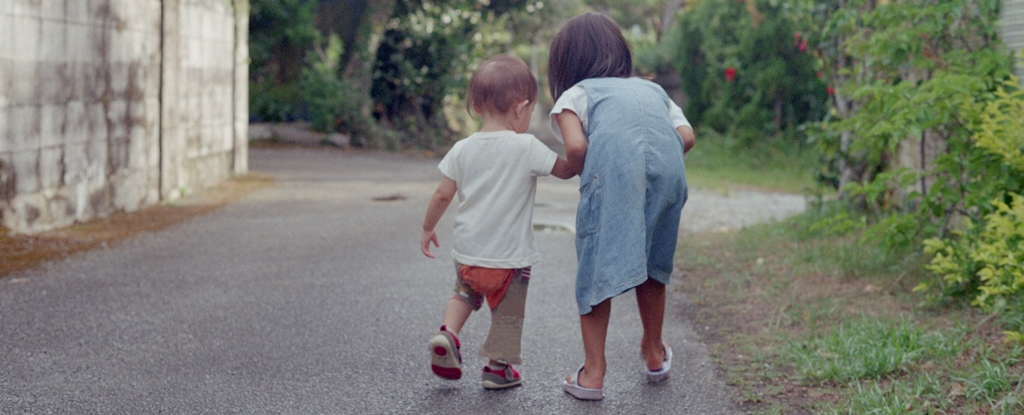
xmin=437 ymin=131 xmax=558 ymax=269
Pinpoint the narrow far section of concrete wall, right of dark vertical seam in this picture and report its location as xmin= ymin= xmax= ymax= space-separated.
xmin=162 ymin=0 xmax=248 ymax=198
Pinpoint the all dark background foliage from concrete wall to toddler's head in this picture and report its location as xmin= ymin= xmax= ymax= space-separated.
xmin=250 ymin=0 xmax=540 ymax=148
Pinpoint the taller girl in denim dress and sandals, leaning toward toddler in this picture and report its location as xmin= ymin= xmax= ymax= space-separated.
xmin=548 ymin=13 xmax=694 ymax=400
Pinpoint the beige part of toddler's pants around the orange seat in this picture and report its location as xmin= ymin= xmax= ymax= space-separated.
xmin=455 ymin=262 xmax=530 ymax=365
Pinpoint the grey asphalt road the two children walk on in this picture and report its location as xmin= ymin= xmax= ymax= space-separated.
xmin=0 ymin=150 xmax=806 ymax=414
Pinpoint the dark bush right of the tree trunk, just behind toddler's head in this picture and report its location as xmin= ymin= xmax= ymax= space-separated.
xmin=371 ymin=0 xmax=522 ymax=149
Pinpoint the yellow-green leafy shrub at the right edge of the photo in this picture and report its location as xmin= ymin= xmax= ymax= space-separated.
xmin=918 ymin=79 xmax=1024 ymax=310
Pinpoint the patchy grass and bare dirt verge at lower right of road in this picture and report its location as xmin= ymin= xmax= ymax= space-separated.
xmin=674 ymin=201 xmax=1024 ymax=414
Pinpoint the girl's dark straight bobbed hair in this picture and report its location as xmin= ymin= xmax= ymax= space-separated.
xmin=548 ymin=12 xmax=633 ymax=100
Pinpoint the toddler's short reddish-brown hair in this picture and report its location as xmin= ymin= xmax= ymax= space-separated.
xmin=466 ymin=54 xmax=539 ymax=114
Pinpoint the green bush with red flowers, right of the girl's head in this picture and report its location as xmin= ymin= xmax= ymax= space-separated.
xmin=676 ymin=0 xmax=826 ymax=142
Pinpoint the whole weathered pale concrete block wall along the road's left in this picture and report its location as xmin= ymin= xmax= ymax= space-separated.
xmin=0 ymin=0 xmax=248 ymax=233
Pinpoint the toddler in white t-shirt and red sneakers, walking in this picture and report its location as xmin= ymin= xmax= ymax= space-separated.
xmin=420 ymin=55 xmax=574 ymax=389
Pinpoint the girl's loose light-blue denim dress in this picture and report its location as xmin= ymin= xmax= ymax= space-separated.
xmin=575 ymin=78 xmax=687 ymax=316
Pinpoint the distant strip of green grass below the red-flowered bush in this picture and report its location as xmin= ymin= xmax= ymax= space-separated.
xmin=686 ymin=131 xmax=820 ymax=194
